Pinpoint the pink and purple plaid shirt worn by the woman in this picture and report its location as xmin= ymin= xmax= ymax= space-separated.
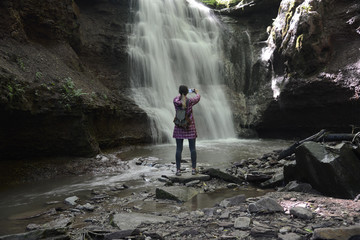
xmin=173 ymin=94 xmax=200 ymax=139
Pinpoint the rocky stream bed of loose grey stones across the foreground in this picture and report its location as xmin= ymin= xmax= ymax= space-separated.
xmin=0 ymin=142 xmax=360 ymax=240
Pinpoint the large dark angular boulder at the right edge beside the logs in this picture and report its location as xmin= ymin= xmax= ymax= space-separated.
xmin=284 ymin=142 xmax=360 ymax=199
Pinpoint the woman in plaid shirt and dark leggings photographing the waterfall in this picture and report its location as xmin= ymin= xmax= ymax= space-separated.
xmin=173 ymin=85 xmax=200 ymax=176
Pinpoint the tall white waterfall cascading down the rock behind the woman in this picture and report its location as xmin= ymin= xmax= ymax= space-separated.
xmin=129 ymin=0 xmax=235 ymax=143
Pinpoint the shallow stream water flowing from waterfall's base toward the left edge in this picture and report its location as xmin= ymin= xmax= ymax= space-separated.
xmin=0 ymin=139 xmax=289 ymax=235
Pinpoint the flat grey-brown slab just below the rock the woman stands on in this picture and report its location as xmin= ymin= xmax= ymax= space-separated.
xmin=156 ymin=186 xmax=199 ymax=202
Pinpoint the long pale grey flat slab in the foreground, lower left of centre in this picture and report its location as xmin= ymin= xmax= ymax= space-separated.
xmin=112 ymin=213 xmax=175 ymax=230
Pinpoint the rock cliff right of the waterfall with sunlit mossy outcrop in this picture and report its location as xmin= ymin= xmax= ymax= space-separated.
xmin=220 ymin=0 xmax=360 ymax=137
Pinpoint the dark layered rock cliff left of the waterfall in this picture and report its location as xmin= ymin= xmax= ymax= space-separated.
xmin=0 ymin=0 xmax=150 ymax=159
